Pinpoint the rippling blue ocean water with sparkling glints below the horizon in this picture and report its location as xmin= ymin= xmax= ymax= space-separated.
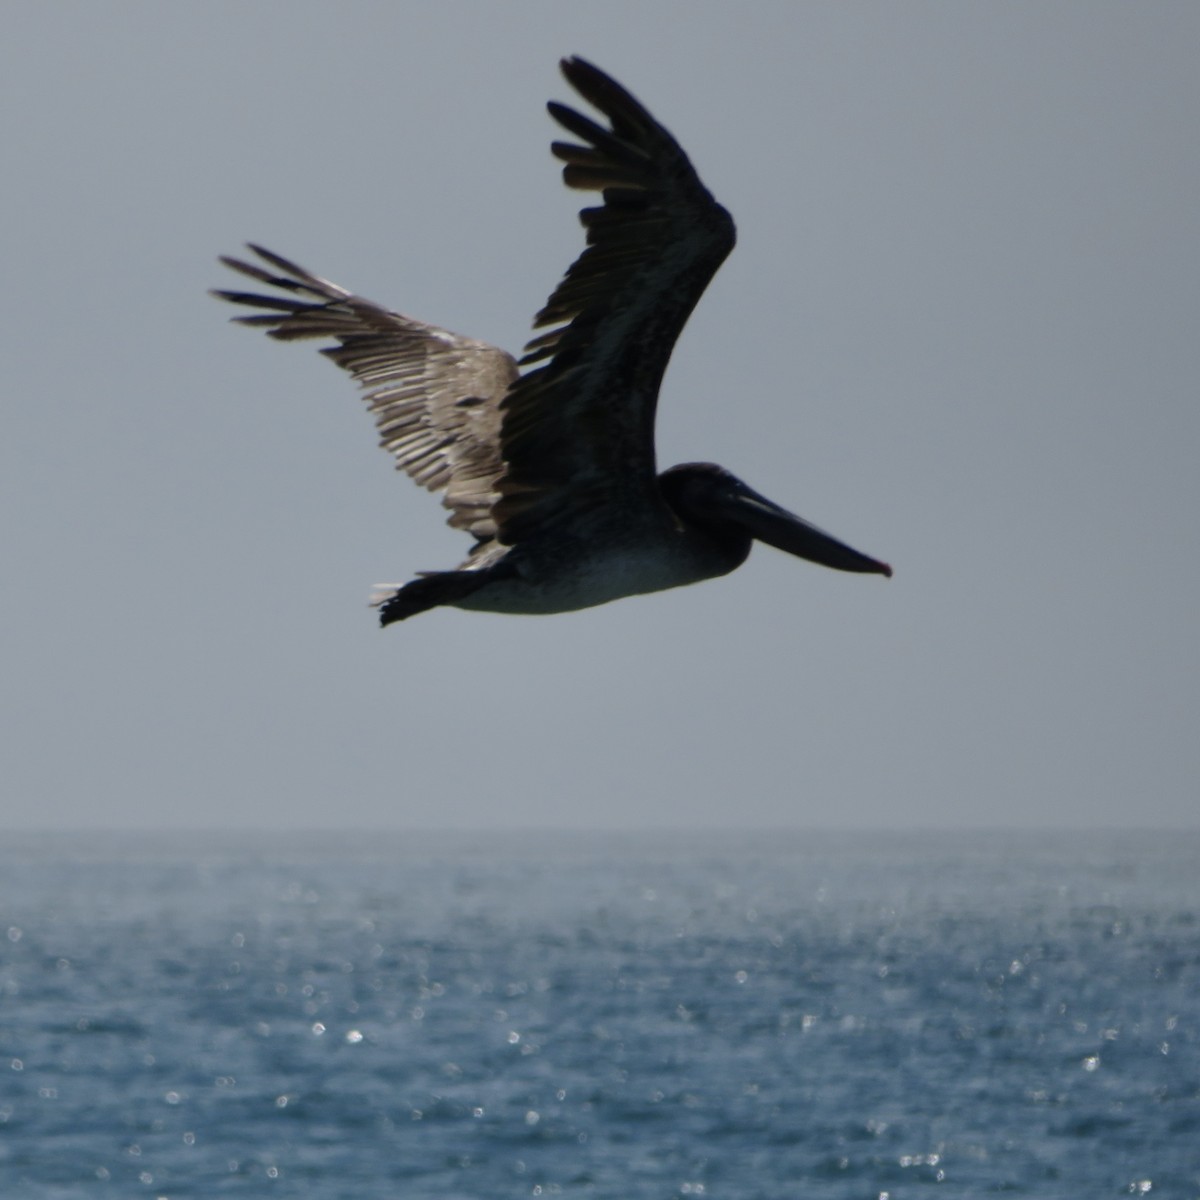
xmin=0 ymin=834 xmax=1200 ymax=1200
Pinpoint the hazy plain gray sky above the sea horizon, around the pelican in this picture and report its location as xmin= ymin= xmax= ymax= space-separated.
xmin=0 ymin=0 xmax=1200 ymax=828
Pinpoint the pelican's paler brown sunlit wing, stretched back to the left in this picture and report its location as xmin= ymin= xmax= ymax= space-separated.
xmin=214 ymin=246 xmax=517 ymax=539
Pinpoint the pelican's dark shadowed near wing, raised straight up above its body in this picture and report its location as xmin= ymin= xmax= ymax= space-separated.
xmin=493 ymin=58 xmax=734 ymax=544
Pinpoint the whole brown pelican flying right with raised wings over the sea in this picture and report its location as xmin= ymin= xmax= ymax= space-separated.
xmin=215 ymin=58 xmax=892 ymax=625
